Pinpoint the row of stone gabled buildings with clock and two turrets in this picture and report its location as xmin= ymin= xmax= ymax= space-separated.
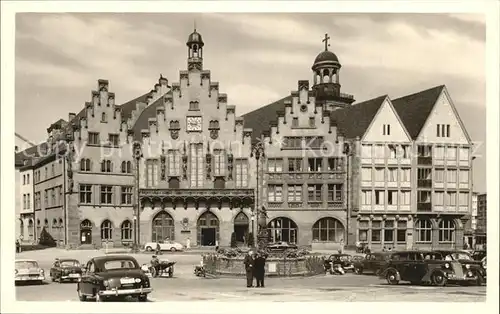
xmin=16 ymin=31 xmax=472 ymax=250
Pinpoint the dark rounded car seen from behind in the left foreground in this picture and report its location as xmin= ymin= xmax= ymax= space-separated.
xmin=76 ymin=255 xmax=153 ymax=302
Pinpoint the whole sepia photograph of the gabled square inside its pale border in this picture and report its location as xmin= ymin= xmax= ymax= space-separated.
xmin=2 ymin=2 xmax=498 ymax=312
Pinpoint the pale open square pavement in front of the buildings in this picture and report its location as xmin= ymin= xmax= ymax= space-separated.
xmin=16 ymin=251 xmax=486 ymax=302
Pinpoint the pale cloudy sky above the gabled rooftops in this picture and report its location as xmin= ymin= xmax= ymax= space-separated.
xmin=15 ymin=13 xmax=486 ymax=192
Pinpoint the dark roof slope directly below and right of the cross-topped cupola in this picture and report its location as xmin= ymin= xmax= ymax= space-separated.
xmin=330 ymin=95 xmax=387 ymax=139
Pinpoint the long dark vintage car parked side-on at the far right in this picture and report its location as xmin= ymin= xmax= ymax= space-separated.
xmin=380 ymin=251 xmax=476 ymax=286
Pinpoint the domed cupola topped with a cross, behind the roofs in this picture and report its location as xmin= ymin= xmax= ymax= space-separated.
xmin=311 ymin=34 xmax=354 ymax=107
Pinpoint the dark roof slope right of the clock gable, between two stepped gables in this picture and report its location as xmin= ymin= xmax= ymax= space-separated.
xmin=241 ymin=95 xmax=293 ymax=141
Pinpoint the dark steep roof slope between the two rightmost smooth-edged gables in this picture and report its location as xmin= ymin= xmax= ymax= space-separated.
xmin=392 ymin=85 xmax=444 ymax=139
